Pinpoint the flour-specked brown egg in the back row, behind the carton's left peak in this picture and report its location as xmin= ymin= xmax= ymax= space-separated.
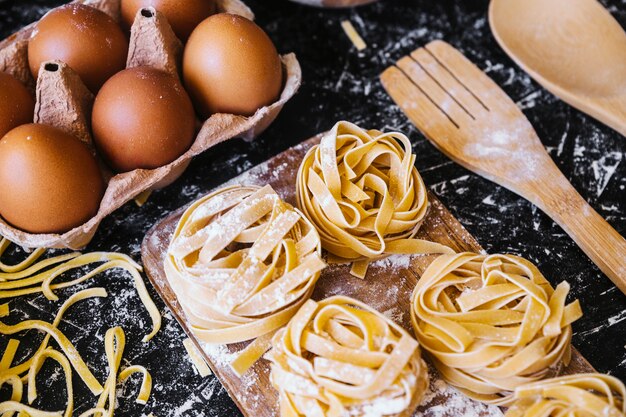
xmin=28 ymin=4 xmax=128 ymax=93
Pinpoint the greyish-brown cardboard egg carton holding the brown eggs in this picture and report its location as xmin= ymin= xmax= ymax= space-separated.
xmin=0 ymin=0 xmax=301 ymax=250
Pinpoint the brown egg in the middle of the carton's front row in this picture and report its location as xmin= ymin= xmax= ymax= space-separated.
xmin=91 ymin=67 xmax=195 ymax=172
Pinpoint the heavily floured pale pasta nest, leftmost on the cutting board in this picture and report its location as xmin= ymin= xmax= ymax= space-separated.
xmin=165 ymin=185 xmax=325 ymax=343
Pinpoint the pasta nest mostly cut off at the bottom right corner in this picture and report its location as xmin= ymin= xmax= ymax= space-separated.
xmin=505 ymin=374 xmax=626 ymax=417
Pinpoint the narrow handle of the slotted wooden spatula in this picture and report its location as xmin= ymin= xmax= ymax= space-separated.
xmin=529 ymin=176 xmax=626 ymax=294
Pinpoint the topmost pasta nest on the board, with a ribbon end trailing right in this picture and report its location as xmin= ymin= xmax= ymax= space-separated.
xmin=296 ymin=122 xmax=453 ymax=278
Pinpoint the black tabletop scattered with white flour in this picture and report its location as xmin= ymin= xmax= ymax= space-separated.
xmin=0 ymin=0 xmax=626 ymax=417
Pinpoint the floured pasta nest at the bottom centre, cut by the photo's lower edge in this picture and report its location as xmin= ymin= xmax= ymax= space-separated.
xmin=266 ymin=296 xmax=428 ymax=417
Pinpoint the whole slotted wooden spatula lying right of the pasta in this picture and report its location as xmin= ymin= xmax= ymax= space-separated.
xmin=381 ymin=41 xmax=626 ymax=294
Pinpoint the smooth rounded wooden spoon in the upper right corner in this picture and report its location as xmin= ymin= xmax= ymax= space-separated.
xmin=489 ymin=0 xmax=626 ymax=135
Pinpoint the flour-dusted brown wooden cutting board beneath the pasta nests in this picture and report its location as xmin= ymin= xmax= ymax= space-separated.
xmin=142 ymin=136 xmax=593 ymax=417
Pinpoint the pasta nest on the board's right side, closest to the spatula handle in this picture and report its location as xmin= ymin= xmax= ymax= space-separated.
xmin=411 ymin=253 xmax=582 ymax=405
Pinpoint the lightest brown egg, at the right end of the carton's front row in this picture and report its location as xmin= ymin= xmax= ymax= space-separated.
xmin=183 ymin=13 xmax=282 ymax=118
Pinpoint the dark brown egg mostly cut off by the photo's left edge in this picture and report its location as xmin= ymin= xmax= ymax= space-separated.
xmin=0 ymin=72 xmax=35 ymax=138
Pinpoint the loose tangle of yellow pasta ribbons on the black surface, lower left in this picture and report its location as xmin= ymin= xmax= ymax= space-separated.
xmin=0 ymin=239 xmax=161 ymax=417
